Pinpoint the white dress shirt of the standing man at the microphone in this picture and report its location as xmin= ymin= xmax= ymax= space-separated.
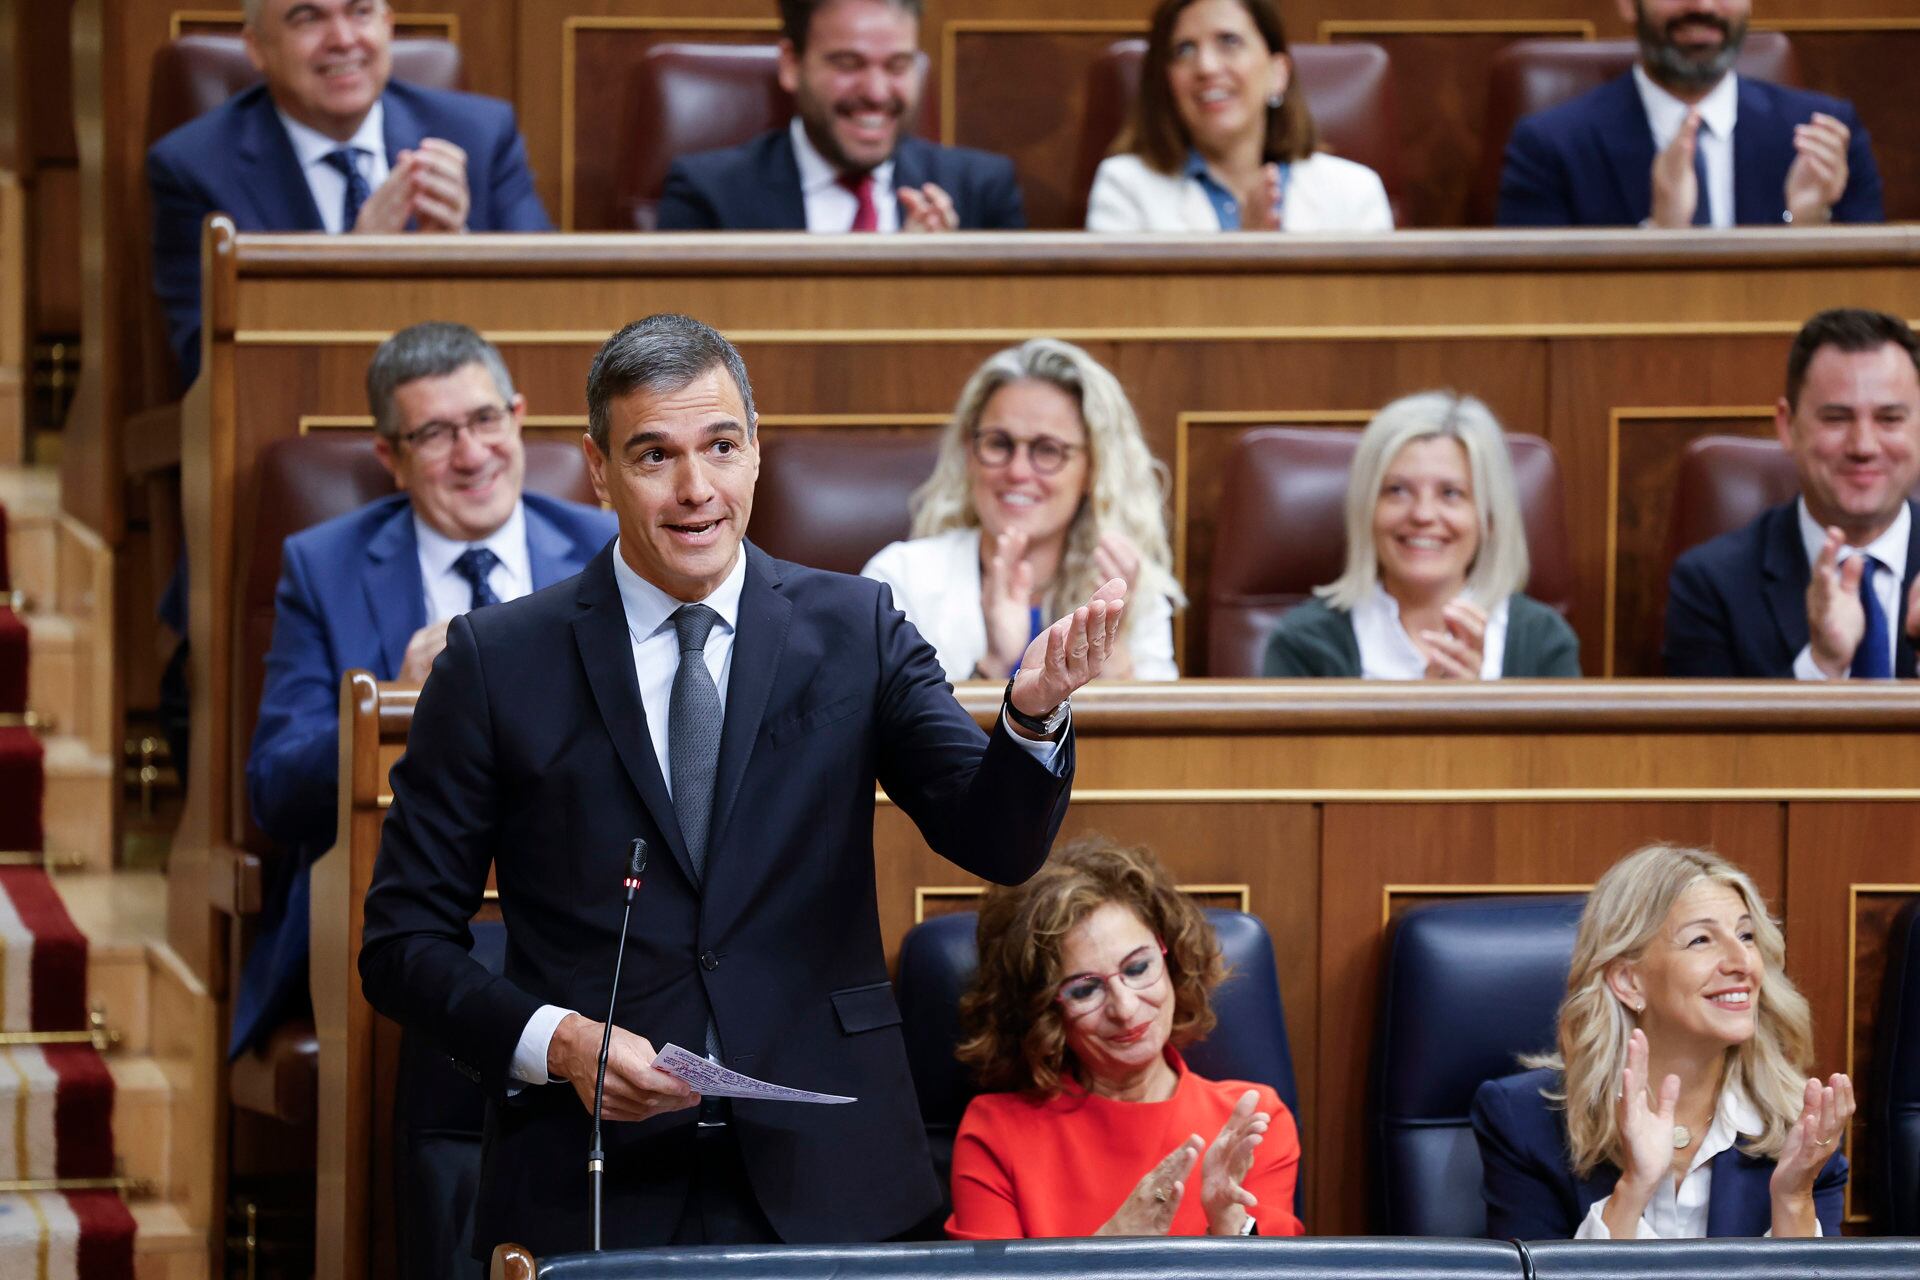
xmin=511 ymin=543 xmax=1066 ymax=1084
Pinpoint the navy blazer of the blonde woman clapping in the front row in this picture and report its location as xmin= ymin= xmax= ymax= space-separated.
xmin=1473 ymin=1071 xmax=1847 ymax=1240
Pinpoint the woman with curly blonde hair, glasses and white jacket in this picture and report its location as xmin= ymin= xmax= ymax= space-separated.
xmin=860 ymin=338 xmax=1187 ymax=681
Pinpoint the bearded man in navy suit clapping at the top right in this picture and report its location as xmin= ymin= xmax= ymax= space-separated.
xmin=1498 ymin=0 xmax=1885 ymax=226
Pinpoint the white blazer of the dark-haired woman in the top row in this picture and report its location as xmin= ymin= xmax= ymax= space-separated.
xmin=1087 ymin=152 xmax=1394 ymax=232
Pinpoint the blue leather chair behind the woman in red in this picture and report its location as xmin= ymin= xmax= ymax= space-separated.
xmin=895 ymin=908 xmax=1304 ymax=1221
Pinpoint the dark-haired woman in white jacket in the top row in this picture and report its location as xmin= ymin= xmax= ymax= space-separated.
xmin=1087 ymin=0 xmax=1394 ymax=232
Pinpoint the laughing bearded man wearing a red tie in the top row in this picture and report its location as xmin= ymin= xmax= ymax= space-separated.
xmin=659 ymin=0 xmax=1027 ymax=232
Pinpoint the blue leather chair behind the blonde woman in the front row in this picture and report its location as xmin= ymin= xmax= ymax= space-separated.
xmin=1373 ymin=894 xmax=1584 ymax=1236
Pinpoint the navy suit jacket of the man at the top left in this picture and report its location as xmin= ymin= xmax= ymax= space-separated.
xmin=146 ymin=81 xmax=553 ymax=386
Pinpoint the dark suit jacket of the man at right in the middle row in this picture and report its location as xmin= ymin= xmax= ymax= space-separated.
xmin=1661 ymin=499 xmax=1920 ymax=679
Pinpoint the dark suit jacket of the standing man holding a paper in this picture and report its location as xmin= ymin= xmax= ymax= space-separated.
xmin=361 ymin=547 xmax=1071 ymax=1257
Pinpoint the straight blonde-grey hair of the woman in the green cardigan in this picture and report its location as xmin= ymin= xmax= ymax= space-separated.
xmin=1313 ymin=391 xmax=1528 ymax=610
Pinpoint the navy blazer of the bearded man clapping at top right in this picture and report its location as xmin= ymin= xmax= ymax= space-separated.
xmin=1496 ymin=73 xmax=1885 ymax=226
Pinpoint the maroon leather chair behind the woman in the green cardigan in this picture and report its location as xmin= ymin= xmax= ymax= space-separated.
xmin=1206 ymin=426 xmax=1572 ymax=676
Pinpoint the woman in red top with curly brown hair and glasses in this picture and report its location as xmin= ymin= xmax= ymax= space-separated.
xmin=947 ymin=837 xmax=1300 ymax=1240
